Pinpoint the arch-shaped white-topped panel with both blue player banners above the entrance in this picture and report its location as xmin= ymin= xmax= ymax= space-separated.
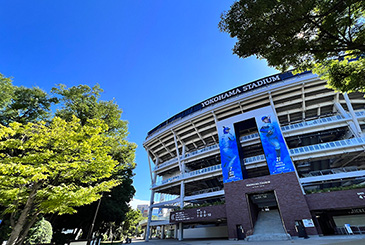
xmin=217 ymin=106 xmax=295 ymax=183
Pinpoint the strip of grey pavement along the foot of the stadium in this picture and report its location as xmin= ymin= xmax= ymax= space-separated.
xmin=132 ymin=235 xmax=365 ymax=245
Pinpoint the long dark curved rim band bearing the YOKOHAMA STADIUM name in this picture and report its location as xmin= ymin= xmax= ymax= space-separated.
xmin=147 ymin=72 xmax=310 ymax=136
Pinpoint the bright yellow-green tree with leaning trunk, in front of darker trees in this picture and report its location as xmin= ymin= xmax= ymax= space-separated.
xmin=0 ymin=117 xmax=120 ymax=245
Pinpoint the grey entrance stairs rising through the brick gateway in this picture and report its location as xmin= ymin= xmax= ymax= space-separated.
xmin=246 ymin=209 xmax=291 ymax=241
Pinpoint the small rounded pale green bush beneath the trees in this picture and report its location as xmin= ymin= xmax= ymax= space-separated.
xmin=27 ymin=218 xmax=52 ymax=244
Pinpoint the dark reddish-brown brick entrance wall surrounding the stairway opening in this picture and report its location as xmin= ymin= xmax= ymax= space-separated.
xmin=224 ymin=172 xmax=318 ymax=239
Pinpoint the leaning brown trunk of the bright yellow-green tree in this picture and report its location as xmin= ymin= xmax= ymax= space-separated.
xmin=7 ymin=183 xmax=40 ymax=245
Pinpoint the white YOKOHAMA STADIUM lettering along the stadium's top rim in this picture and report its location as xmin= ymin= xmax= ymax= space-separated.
xmin=202 ymin=75 xmax=280 ymax=108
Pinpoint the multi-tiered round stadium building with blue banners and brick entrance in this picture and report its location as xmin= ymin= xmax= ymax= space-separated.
xmin=144 ymin=72 xmax=365 ymax=240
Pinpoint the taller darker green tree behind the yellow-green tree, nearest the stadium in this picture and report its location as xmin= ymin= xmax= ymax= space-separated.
xmin=52 ymin=84 xmax=136 ymax=238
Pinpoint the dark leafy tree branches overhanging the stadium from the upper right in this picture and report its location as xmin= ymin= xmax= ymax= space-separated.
xmin=219 ymin=0 xmax=365 ymax=92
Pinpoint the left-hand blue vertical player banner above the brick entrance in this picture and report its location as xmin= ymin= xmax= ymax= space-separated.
xmin=217 ymin=119 xmax=243 ymax=183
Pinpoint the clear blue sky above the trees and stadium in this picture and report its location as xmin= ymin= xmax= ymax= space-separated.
xmin=0 ymin=0 xmax=277 ymax=205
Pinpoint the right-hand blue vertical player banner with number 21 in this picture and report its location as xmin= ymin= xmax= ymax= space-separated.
xmin=255 ymin=106 xmax=294 ymax=174
